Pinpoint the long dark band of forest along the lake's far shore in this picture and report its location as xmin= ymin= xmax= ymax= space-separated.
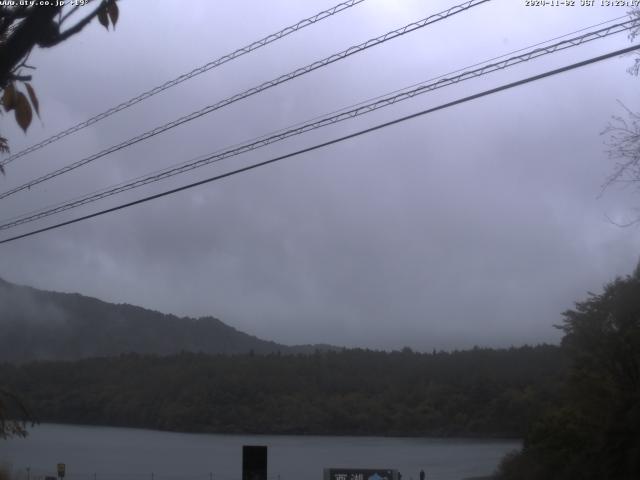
xmin=0 ymin=345 xmax=566 ymax=436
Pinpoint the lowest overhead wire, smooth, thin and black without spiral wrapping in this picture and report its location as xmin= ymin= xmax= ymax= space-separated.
xmin=0 ymin=45 xmax=640 ymax=245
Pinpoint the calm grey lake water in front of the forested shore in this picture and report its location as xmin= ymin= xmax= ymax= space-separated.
xmin=0 ymin=424 xmax=520 ymax=480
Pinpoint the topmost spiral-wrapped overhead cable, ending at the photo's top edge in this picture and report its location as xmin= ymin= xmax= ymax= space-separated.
xmin=0 ymin=0 xmax=364 ymax=166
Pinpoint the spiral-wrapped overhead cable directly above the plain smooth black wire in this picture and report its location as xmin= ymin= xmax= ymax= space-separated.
xmin=0 ymin=16 xmax=640 ymax=230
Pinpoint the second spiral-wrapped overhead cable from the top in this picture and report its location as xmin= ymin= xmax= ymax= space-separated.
xmin=0 ymin=0 xmax=491 ymax=199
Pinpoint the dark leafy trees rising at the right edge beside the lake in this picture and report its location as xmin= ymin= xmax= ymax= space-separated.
xmin=500 ymin=265 xmax=640 ymax=480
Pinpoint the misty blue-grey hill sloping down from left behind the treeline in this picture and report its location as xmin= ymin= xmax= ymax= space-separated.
xmin=0 ymin=279 xmax=337 ymax=363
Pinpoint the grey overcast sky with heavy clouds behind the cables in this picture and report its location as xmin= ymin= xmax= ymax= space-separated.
xmin=0 ymin=0 xmax=640 ymax=350
